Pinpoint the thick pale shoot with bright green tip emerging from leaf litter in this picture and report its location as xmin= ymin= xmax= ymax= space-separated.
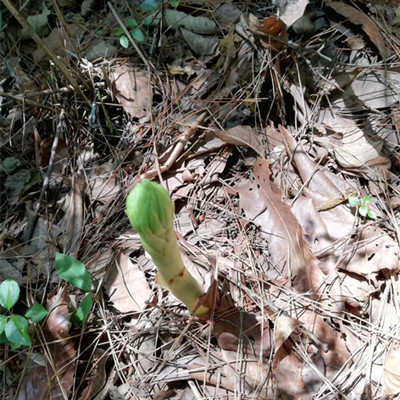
xmin=126 ymin=179 xmax=209 ymax=315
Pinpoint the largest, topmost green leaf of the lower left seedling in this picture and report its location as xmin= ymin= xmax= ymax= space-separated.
xmin=55 ymin=253 xmax=91 ymax=292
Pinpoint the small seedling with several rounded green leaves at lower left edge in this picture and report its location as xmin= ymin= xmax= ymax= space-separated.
xmin=0 ymin=253 xmax=93 ymax=350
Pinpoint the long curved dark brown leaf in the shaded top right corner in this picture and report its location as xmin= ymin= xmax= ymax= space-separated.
xmin=326 ymin=1 xmax=387 ymax=60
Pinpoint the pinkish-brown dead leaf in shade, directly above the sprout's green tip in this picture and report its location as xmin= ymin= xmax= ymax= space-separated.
xmin=110 ymin=65 xmax=152 ymax=118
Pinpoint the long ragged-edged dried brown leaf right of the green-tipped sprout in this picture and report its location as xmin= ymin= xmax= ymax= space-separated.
xmin=238 ymin=158 xmax=323 ymax=293
